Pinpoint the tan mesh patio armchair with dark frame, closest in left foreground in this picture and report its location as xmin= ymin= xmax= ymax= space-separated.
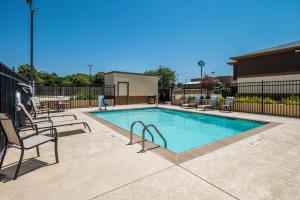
xmin=0 ymin=113 xmax=59 ymax=180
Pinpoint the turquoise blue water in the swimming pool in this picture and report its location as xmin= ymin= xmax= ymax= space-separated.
xmin=92 ymin=108 xmax=265 ymax=153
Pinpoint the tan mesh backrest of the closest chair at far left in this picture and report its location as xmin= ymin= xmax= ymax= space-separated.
xmin=0 ymin=113 xmax=21 ymax=146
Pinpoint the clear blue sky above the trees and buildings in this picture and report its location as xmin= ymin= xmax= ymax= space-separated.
xmin=0 ymin=0 xmax=300 ymax=81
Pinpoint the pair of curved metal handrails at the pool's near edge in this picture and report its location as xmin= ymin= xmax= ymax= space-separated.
xmin=128 ymin=121 xmax=167 ymax=152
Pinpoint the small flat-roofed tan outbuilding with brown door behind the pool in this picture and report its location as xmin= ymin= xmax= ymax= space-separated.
xmin=104 ymin=71 xmax=158 ymax=105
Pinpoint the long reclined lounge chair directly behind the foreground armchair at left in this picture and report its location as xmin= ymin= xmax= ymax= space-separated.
xmin=17 ymin=103 xmax=91 ymax=132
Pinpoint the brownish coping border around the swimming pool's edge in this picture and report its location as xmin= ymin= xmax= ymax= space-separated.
xmin=83 ymin=107 xmax=282 ymax=164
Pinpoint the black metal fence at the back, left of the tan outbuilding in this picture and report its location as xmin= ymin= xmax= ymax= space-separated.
xmin=34 ymin=85 xmax=115 ymax=108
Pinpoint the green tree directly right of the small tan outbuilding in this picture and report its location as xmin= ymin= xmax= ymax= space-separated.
xmin=144 ymin=65 xmax=176 ymax=88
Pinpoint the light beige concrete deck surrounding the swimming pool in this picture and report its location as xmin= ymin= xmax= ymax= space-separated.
xmin=0 ymin=105 xmax=300 ymax=200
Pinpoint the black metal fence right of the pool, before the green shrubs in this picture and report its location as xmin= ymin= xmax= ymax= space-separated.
xmin=172 ymin=80 xmax=300 ymax=117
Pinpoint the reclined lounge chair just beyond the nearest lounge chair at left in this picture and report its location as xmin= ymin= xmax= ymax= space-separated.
xmin=30 ymin=97 xmax=77 ymax=120
